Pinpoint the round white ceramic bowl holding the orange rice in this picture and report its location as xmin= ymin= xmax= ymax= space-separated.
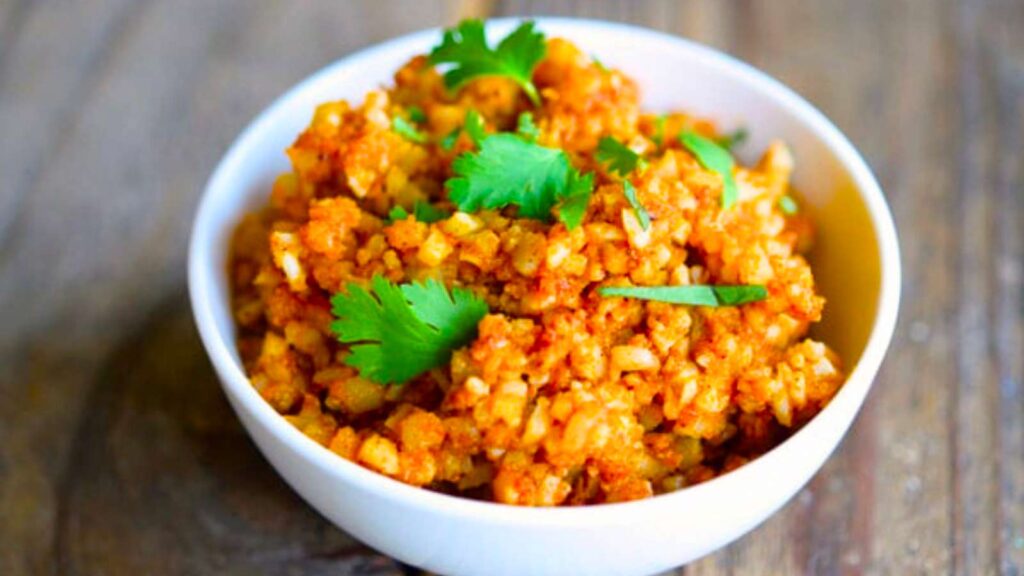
xmin=188 ymin=18 xmax=900 ymax=575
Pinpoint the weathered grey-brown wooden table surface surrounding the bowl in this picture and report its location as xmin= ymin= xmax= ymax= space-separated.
xmin=0 ymin=0 xmax=1024 ymax=576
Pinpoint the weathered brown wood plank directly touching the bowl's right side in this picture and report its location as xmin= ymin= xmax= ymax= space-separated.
xmin=864 ymin=3 xmax=958 ymax=574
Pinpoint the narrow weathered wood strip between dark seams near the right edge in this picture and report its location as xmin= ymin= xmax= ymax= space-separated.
xmin=951 ymin=3 xmax=999 ymax=574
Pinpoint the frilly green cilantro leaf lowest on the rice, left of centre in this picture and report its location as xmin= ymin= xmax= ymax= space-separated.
xmin=331 ymin=276 xmax=487 ymax=384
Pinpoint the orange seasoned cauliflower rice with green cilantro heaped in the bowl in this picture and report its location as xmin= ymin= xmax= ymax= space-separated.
xmin=229 ymin=20 xmax=844 ymax=506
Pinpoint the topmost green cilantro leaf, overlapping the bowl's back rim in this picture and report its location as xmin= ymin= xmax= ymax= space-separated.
xmin=429 ymin=19 xmax=548 ymax=105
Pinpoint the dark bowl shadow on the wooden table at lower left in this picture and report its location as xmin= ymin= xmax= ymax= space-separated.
xmin=55 ymin=292 xmax=418 ymax=575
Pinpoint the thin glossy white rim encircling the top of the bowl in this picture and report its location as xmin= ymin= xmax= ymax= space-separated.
xmin=188 ymin=16 xmax=901 ymax=527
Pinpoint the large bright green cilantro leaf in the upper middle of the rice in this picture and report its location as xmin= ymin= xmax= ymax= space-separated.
xmin=446 ymin=133 xmax=594 ymax=220
